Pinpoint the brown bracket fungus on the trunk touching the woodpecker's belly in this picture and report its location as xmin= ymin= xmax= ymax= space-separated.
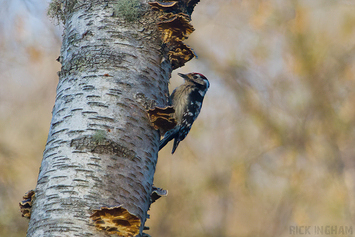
xmin=147 ymin=106 xmax=176 ymax=134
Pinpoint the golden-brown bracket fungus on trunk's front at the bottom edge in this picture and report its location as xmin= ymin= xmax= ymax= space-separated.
xmin=90 ymin=206 xmax=141 ymax=237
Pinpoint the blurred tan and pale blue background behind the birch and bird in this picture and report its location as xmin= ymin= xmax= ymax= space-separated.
xmin=0 ymin=0 xmax=355 ymax=237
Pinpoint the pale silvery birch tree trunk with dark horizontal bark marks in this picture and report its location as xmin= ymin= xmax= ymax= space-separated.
xmin=27 ymin=0 xmax=200 ymax=237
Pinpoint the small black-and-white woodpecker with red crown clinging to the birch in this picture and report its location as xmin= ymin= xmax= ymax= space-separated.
xmin=159 ymin=72 xmax=210 ymax=154
